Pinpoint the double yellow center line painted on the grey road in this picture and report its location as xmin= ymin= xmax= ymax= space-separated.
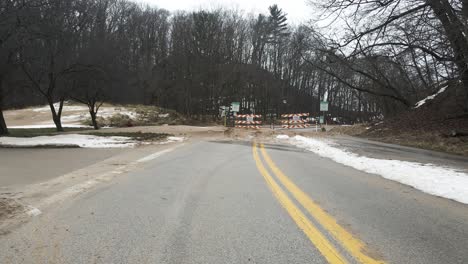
xmin=252 ymin=144 xmax=384 ymax=264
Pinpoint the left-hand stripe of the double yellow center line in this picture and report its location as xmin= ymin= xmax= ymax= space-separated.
xmin=252 ymin=143 xmax=347 ymax=264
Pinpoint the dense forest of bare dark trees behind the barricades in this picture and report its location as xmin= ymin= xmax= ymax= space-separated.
xmin=0 ymin=0 xmax=468 ymax=134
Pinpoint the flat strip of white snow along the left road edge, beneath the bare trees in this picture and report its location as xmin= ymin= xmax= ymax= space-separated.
xmin=0 ymin=134 xmax=137 ymax=148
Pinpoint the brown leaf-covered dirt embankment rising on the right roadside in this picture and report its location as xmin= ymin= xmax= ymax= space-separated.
xmin=332 ymin=82 xmax=468 ymax=156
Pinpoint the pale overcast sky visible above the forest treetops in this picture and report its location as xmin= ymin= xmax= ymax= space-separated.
xmin=133 ymin=0 xmax=313 ymax=24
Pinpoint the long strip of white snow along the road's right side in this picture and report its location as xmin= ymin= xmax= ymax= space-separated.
xmin=277 ymin=135 xmax=468 ymax=204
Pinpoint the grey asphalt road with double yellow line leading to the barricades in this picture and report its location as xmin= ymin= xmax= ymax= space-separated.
xmin=0 ymin=141 xmax=468 ymax=264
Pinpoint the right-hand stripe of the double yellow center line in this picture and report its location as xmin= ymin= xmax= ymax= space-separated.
xmin=260 ymin=144 xmax=385 ymax=264
